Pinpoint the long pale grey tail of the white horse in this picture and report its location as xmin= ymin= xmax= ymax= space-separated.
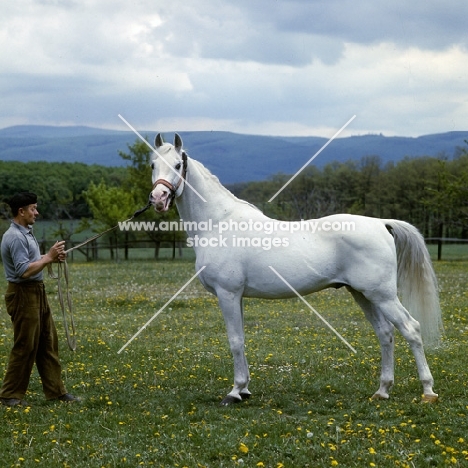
xmin=384 ymin=220 xmax=443 ymax=348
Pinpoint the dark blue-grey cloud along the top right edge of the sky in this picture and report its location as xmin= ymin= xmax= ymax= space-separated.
xmin=243 ymin=0 xmax=468 ymax=49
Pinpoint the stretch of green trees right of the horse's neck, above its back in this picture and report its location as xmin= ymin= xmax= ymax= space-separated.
xmin=233 ymin=149 xmax=468 ymax=238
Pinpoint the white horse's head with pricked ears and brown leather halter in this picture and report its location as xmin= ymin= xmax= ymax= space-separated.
xmin=149 ymin=133 xmax=187 ymax=212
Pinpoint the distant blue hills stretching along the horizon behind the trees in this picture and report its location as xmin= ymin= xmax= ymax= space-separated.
xmin=0 ymin=125 xmax=468 ymax=184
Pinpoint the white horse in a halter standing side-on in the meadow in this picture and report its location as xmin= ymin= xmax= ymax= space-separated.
xmin=150 ymin=134 xmax=442 ymax=405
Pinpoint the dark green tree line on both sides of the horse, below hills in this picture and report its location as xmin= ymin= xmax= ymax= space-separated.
xmin=0 ymin=140 xmax=468 ymax=242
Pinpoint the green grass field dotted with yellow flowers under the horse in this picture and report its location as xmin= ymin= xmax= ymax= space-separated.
xmin=0 ymin=261 xmax=468 ymax=468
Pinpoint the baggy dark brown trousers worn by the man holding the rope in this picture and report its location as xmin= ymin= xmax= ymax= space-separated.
xmin=0 ymin=282 xmax=66 ymax=400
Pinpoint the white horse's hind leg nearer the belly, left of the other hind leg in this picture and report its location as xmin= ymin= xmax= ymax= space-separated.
xmin=348 ymin=287 xmax=395 ymax=400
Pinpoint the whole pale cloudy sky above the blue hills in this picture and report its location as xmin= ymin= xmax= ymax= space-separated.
xmin=0 ymin=0 xmax=468 ymax=137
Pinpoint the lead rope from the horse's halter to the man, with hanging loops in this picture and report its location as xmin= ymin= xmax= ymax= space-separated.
xmin=47 ymin=202 xmax=151 ymax=351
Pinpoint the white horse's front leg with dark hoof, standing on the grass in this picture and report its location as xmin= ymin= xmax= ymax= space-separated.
xmin=218 ymin=291 xmax=251 ymax=405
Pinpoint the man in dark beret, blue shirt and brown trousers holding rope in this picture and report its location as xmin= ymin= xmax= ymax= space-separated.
xmin=0 ymin=192 xmax=79 ymax=406
